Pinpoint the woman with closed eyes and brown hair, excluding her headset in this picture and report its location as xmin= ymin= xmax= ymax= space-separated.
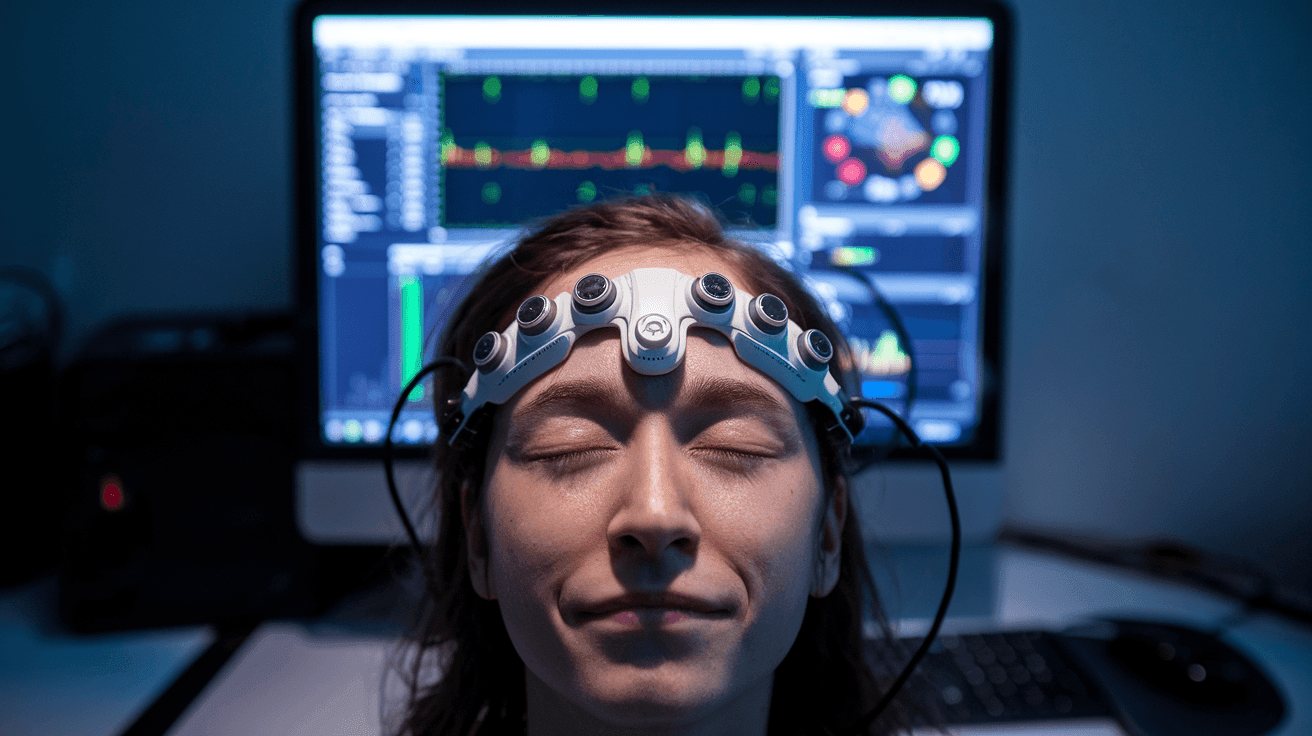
xmin=401 ymin=197 xmax=923 ymax=736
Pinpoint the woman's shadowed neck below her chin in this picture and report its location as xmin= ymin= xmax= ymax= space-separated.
xmin=525 ymin=669 xmax=774 ymax=736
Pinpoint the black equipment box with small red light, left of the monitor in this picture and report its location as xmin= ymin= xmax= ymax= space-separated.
xmin=56 ymin=315 xmax=316 ymax=631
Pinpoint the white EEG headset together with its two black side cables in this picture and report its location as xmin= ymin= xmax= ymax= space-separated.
xmin=383 ymin=269 xmax=962 ymax=735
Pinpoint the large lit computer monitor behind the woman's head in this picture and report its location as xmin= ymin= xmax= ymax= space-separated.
xmin=295 ymin=0 xmax=1009 ymax=543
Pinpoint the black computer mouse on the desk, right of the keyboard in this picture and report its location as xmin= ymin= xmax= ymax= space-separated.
xmin=1060 ymin=619 xmax=1284 ymax=736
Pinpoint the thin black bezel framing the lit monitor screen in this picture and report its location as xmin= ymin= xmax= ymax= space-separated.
xmin=291 ymin=0 xmax=1014 ymax=462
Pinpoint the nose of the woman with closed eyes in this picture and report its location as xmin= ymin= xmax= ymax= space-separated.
xmin=606 ymin=426 xmax=702 ymax=564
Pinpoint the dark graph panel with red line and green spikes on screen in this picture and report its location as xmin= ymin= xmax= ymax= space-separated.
xmin=437 ymin=75 xmax=779 ymax=227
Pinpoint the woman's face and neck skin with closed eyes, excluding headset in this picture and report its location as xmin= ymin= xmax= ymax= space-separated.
xmin=466 ymin=248 xmax=846 ymax=731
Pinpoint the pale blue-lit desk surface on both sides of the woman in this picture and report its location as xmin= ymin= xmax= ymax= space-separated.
xmin=0 ymin=548 xmax=1312 ymax=736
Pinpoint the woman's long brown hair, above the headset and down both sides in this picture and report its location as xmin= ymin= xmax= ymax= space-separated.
xmin=400 ymin=195 xmax=923 ymax=736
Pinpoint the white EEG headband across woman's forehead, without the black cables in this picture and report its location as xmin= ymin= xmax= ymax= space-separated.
xmin=443 ymin=269 xmax=865 ymax=445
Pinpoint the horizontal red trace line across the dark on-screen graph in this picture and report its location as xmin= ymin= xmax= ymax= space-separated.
xmin=442 ymin=144 xmax=779 ymax=172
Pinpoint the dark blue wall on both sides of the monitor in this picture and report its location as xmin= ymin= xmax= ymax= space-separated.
xmin=0 ymin=0 xmax=1312 ymax=588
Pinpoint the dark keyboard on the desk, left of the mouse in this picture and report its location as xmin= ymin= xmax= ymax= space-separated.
xmin=866 ymin=631 xmax=1113 ymax=726
